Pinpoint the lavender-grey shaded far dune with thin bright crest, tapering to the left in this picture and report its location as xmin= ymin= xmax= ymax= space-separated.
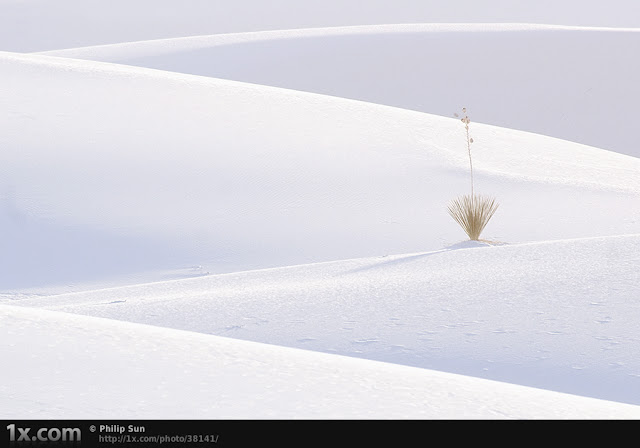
xmin=40 ymin=23 xmax=640 ymax=157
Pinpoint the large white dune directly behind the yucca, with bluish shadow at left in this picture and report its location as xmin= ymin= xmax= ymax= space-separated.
xmin=0 ymin=53 xmax=640 ymax=290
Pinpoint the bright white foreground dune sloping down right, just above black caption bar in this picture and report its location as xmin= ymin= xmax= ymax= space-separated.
xmin=0 ymin=306 xmax=640 ymax=419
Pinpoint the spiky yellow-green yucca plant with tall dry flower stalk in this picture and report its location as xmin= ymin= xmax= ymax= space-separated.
xmin=449 ymin=108 xmax=498 ymax=241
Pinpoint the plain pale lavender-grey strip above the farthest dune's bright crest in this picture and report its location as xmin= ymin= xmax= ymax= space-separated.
xmin=0 ymin=0 xmax=640 ymax=52
